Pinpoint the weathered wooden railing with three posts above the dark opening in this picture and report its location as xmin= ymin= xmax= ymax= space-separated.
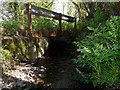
xmin=24 ymin=3 xmax=76 ymax=35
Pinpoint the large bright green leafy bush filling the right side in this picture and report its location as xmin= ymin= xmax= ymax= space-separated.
xmin=74 ymin=16 xmax=120 ymax=87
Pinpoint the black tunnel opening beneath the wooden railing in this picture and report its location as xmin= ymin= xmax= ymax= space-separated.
xmin=45 ymin=37 xmax=72 ymax=57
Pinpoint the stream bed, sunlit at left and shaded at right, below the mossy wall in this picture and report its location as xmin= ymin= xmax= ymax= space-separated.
xmin=2 ymin=57 xmax=74 ymax=90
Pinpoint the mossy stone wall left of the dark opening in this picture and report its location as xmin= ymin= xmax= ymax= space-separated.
xmin=2 ymin=36 xmax=48 ymax=60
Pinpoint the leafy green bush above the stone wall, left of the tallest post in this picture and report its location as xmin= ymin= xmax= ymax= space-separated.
xmin=2 ymin=17 xmax=27 ymax=36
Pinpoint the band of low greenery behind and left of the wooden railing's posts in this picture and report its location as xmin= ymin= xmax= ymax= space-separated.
xmin=2 ymin=16 xmax=74 ymax=36
